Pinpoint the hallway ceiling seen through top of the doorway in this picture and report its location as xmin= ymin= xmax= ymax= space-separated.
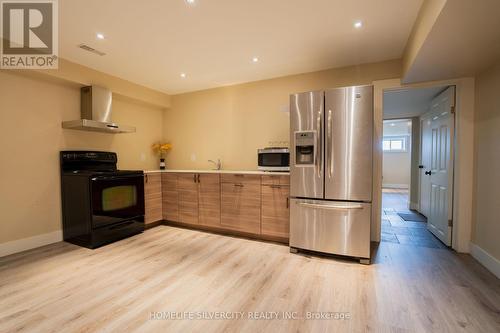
xmin=384 ymin=87 xmax=446 ymax=119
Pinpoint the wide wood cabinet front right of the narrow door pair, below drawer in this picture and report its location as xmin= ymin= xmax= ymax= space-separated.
xmin=221 ymin=183 xmax=261 ymax=234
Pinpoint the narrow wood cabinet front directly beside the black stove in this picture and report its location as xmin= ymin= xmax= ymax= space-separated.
xmin=144 ymin=173 xmax=163 ymax=224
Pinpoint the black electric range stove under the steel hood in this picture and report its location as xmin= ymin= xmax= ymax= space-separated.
xmin=60 ymin=151 xmax=144 ymax=249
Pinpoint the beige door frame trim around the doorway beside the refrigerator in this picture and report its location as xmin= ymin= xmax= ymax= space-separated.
xmin=371 ymin=78 xmax=474 ymax=253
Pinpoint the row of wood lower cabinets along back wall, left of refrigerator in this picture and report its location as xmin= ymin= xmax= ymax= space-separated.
xmin=156 ymin=172 xmax=290 ymax=241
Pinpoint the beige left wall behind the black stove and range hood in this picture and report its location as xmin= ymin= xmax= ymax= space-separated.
xmin=0 ymin=71 xmax=163 ymax=244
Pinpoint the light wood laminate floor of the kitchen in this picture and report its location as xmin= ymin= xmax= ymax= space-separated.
xmin=0 ymin=226 xmax=500 ymax=332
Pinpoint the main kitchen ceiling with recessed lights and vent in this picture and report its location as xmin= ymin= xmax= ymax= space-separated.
xmin=59 ymin=0 xmax=422 ymax=94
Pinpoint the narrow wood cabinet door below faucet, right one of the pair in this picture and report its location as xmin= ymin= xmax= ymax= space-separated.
xmin=198 ymin=173 xmax=221 ymax=227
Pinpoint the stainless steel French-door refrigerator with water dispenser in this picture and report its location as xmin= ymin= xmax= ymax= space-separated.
xmin=290 ymin=86 xmax=373 ymax=263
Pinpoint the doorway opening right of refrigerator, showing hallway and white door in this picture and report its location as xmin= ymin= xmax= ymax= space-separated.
xmin=381 ymin=86 xmax=455 ymax=248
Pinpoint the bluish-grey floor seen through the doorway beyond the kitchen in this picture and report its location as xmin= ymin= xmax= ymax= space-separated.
xmin=382 ymin=189 xmax=446 ymax=249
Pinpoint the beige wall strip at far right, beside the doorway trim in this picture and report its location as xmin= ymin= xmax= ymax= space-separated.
xmin=473 ymin=61 xmax=500 ymax=260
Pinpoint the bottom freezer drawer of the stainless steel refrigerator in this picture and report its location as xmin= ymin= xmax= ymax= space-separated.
xmin=290 ymin=199 xmax=371 ymax=258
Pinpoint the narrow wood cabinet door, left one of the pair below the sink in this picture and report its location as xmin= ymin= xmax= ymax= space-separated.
xmin=177 ymin=173 xmax=198 ymax=224
